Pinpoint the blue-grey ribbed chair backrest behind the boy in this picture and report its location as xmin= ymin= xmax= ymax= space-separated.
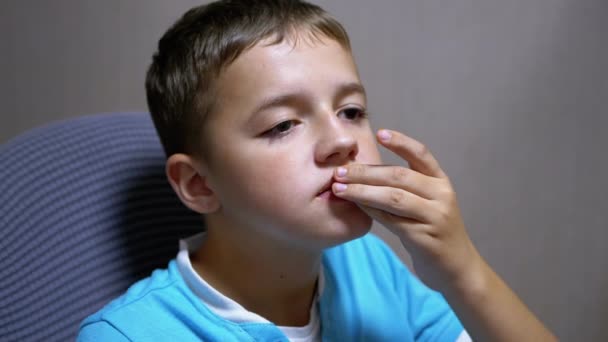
xmin=0 ymin=113 xmax=203 ymax=341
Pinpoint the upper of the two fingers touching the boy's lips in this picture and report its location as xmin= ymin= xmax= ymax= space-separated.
xmin=334 ymin=164 xmax=443 ymax=199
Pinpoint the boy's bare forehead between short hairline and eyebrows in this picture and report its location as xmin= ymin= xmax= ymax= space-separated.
xmin=216 ymin=37 xmax=360 ymax=102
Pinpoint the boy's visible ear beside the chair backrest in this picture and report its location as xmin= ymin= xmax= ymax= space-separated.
xmin=165 ymin=153 xmax=220 ymax=214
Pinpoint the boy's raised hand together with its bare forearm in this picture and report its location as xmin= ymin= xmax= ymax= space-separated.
xmin=333 ymin=130 xmax=557 ymax=341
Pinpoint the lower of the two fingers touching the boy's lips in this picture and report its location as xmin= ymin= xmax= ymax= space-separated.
xmin=332 ymin=183 xmax=433 ymax=223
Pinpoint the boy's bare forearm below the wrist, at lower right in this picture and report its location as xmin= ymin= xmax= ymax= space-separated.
xmin=444 ymin=257 xmax=557 ymax=342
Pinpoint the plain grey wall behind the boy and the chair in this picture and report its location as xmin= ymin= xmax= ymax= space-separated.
xmin=0 ymin=0 xmax=608 ymax=341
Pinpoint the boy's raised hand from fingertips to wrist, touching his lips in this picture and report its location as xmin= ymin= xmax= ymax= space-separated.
xmin=332 ymin=130 xmax=482 ymax=292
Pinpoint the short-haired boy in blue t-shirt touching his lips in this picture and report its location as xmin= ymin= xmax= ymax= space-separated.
xmin=79 ymin=0 xmax=554 ymax=341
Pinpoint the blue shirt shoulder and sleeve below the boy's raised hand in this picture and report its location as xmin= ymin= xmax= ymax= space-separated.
xmin=321 ymin=233 xmax=463 ymax=341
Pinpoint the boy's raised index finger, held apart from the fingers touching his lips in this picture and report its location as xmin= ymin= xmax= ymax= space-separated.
xmin=377 ymin=129 xmax=447 ymax=178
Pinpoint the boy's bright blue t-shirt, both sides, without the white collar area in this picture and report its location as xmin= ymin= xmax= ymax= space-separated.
xmin=78 ymin=234 xmax=463 ymax=341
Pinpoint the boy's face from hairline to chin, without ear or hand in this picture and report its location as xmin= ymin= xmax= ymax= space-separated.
xmin=205 ymin=34 xmax=380 ymax=248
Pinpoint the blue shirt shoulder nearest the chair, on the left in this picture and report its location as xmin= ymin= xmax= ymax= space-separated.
xmin=78 ymin=260 xmax=290 ymax=341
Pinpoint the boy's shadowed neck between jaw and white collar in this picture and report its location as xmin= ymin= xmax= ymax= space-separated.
xmin=191 ymin=216 xmax=322 ymax=326
